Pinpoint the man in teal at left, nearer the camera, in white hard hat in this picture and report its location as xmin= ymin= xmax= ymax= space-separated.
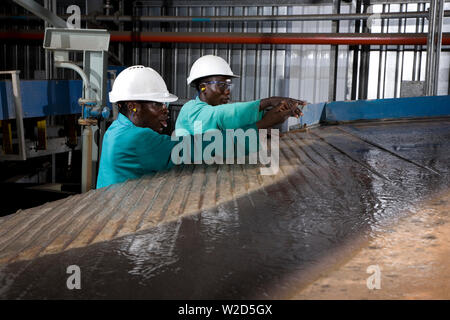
xmin=97 ymin=66 xmax=298 ymax=188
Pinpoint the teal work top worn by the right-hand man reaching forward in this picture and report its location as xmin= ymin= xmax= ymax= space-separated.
xmin=175 ymin=96 xmax=263 ymax=136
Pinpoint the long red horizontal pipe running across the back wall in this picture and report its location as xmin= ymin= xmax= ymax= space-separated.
xmin=0 ymin=31 xmax=450 ymax=45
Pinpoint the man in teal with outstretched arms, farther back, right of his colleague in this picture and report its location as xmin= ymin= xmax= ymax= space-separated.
xmin=175 ymin=55 xmax=306 ymax=136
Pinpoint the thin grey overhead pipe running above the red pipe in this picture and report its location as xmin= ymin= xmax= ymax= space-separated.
xmin=0 ymin=10 xmax=450 ymax=23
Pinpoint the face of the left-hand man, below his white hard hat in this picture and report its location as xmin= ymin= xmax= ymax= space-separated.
xmin=128 ymin=101 xmax=169 ymax=133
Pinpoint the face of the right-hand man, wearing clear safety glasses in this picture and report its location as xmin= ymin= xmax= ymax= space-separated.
xmin=199 ymin=76 xmax=231 ymax=106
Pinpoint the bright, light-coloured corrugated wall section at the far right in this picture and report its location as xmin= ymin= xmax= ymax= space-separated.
xmin=367 ymin=2 xmax=450 ymax=99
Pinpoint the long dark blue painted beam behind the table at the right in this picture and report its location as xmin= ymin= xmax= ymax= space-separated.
xmin=325 ymin=95 xmax=450 ymax=123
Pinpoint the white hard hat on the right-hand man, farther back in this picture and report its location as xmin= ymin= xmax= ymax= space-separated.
xmin=187 ymin=55 xmax=239 ymax=86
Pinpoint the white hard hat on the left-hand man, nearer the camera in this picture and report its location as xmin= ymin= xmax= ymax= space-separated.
xmin=109 ymin=66 xmax=178 ymax=102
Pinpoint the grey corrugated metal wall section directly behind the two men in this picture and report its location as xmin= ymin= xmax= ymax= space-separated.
xmin=133 ymin=1 xmax=354 ymax=102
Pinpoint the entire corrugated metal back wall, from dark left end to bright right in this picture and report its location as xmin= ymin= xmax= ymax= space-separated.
xmin=0 ymin=0 xmax=450 ymax=102
